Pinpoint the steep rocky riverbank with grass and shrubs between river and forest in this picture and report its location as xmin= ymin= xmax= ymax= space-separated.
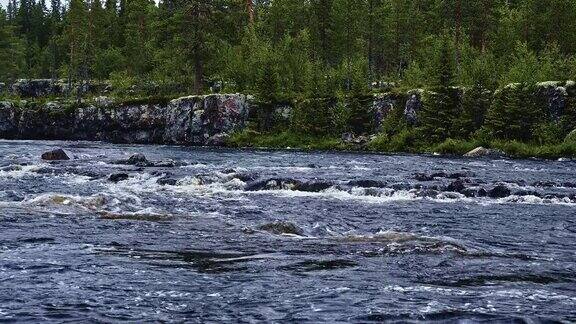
xmin=0 ymin=81 xmax=576 ymax=158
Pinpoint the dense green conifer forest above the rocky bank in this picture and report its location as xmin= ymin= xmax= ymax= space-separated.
xmin=0 ymin=0 xmax=576 ymax=100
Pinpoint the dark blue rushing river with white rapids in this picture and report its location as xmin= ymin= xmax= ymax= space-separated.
xmin=0 ymin=141 xmax=576 ymax=323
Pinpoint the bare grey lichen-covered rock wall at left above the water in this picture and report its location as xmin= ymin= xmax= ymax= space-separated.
xmin=0 ymin=94 xmax=249 ymax=145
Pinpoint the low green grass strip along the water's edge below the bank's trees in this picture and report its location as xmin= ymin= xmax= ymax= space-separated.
xmin=228 ymin=130 xmax=576 ymax=159
